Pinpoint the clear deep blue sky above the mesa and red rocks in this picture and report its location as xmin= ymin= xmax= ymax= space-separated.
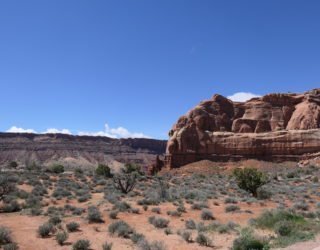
xmin=0 ymin=0 xmax=320 ymax=138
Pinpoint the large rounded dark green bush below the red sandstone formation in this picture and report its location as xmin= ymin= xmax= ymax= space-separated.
xmin=233 ymin=168 xmax=268 ymax=197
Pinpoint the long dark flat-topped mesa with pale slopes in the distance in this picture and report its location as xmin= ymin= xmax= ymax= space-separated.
xmin=0 ymin=133 xmax=166 ymax=167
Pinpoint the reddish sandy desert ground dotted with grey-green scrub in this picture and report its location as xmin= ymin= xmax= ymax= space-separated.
xmin=0 ymin=161 xmax=320 ymax=250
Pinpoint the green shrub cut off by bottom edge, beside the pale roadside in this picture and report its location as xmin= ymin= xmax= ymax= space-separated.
xmin=232 ymin=228 xmax=269 ymax=250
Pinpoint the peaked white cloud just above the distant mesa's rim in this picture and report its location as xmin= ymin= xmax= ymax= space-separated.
xmin=78 ymin=123 xmax=150 ymax=138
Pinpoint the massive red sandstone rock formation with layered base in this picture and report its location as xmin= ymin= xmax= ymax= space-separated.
xmin=165 ymin=89 xmax=320 ymax=168
